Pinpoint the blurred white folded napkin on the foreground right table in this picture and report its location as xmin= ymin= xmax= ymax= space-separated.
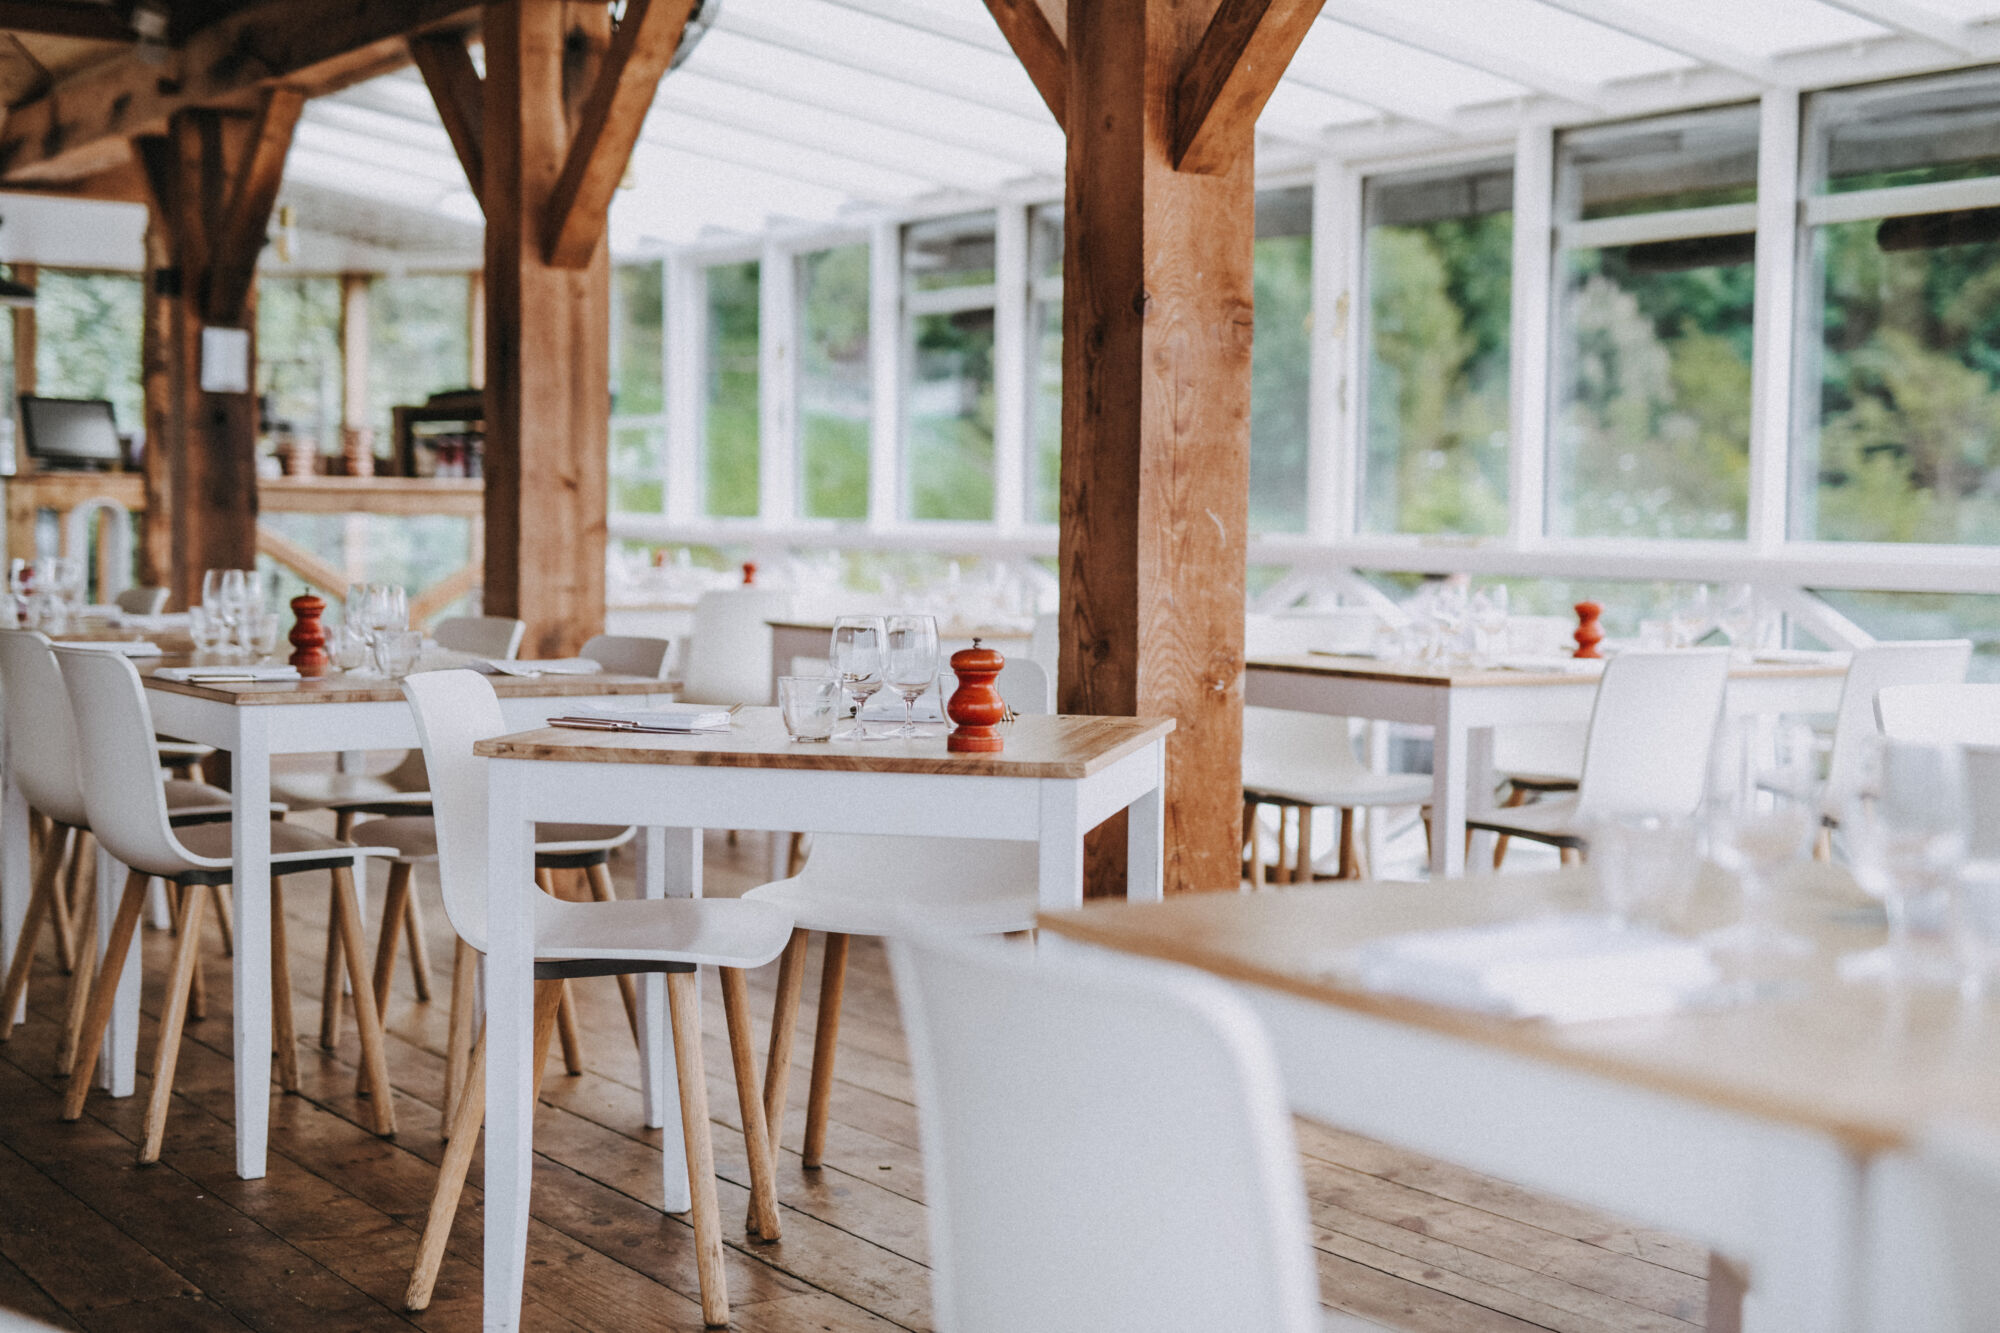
xmin=1328 ymin=917 xmax=1720 ymax=1023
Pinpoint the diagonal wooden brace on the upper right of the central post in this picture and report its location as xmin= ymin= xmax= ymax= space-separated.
xmin=1172 ymin=0 xmax=1324 ymax=174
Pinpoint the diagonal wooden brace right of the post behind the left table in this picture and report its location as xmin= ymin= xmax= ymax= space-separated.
xmin=542 ymin=0 xmax=694 ymax=268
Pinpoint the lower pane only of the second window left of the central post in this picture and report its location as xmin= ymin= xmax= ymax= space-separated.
xmin=904 ymin=308 xmax=994 ymax=520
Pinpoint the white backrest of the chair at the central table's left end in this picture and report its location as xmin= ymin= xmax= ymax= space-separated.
xmin=402 ymin=671 xmax=506 ymax=953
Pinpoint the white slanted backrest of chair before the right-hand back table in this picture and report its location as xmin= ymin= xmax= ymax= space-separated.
xmin=1576 ymin=648 xmax=1730 ymax=817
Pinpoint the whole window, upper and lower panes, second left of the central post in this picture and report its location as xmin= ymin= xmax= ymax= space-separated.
xmin=902 ymin=212 xmax=994 ymax=522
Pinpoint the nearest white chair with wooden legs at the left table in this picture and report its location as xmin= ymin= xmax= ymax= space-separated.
xmin=56 ymin=648 xmax=396 ymax=1163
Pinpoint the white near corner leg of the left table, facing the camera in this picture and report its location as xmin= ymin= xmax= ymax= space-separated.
xmin=230 ymin=709 xmax=270 ymax=1181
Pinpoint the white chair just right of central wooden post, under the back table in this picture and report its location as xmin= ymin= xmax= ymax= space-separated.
xmin=1242 ymin=707 xmax=1432 ymax=883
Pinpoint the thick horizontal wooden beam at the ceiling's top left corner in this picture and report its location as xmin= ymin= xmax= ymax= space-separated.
xmin=0 ymin=0 xmax=480 ymax=182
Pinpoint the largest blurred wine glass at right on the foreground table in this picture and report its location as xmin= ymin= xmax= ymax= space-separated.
xmin=1840 ymin=737 xmax=1968 ymax=981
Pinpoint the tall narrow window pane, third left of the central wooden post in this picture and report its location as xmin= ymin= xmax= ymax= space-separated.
xmin=798 ymin=244 xmax=874 ymax=518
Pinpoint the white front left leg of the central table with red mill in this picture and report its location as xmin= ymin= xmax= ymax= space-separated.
xmin=484 ymin=763 xmax=534 ymax=1333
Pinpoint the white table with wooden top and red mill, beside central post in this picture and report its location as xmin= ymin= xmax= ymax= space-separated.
xmin=474 ymin=709 xmax=1174 ymax=1331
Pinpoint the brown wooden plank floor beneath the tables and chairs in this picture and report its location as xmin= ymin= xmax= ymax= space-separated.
xmin=0 ymin=835 xmax=1706 ymax=1333
